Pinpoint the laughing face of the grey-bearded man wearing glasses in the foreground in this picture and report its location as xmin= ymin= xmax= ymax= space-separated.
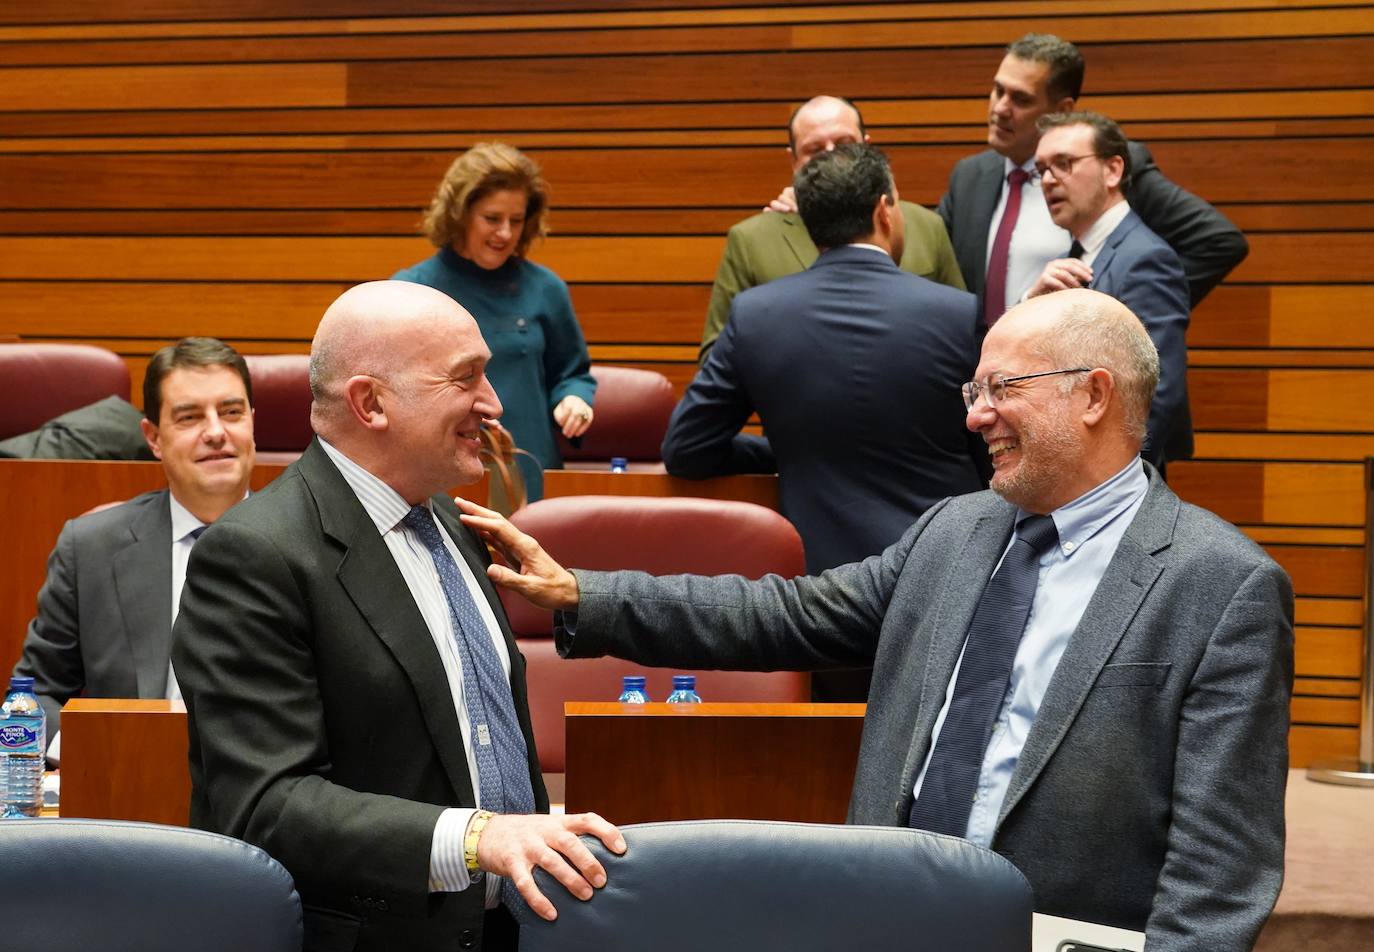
xmin=967 ymin=315 xmax=1095 ymax=514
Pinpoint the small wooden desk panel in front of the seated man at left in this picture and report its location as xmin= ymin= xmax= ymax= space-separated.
xmin=58 ymin=698 xmax=191 ymax=827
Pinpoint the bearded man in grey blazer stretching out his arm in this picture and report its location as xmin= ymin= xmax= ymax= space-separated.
xmin=463 ymin=290 xmax=1293 ymax=952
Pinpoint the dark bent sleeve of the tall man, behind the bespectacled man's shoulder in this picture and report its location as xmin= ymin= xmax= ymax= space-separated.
xmin=1127 ymin=143 xmax=1250 ymax=306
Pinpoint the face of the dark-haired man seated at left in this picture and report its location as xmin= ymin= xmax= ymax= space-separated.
xmin=143 ymin=365 xmax=254 ymax=522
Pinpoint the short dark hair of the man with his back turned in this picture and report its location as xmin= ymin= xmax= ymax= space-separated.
xmin=791 ymin=143 xmax=896 ymax=249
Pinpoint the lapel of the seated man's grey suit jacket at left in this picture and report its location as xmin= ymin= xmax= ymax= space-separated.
xmin=111 ymin=492 xmax=172 ymax=698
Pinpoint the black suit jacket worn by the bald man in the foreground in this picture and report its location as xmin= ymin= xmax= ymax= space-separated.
xmin=173 ymin=441 xmax=548 ymax=951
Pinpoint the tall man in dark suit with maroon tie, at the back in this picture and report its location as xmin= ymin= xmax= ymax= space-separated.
xmin=938 ymin=33 xmax=1249 ymax=323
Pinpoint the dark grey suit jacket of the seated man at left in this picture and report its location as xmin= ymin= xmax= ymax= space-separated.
xmin=14 ymin=489 xmax=172 ymax=739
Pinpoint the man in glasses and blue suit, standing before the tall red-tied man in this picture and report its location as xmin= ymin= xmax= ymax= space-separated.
xmin=1026 ymin=113 xmax=1193 ymax=470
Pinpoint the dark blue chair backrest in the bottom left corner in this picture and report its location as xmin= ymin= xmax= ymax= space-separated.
xmin=0 ymin=820 xmax=302 ymax=952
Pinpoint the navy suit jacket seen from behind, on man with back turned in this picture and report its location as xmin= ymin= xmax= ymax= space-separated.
xmin=664 ymin=247 xmax=985 ymax=571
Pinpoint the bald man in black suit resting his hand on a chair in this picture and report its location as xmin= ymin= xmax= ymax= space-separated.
xmin=173 ymin=282 xmax=624 ymax=951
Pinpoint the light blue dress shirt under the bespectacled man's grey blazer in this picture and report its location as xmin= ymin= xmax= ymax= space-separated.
xmin=915 ymin=459 xmax=1150 ymax=846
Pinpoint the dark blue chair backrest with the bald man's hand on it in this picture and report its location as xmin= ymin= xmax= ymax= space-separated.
xmin=515 ymin=820 xmax=1033 ymax=952
